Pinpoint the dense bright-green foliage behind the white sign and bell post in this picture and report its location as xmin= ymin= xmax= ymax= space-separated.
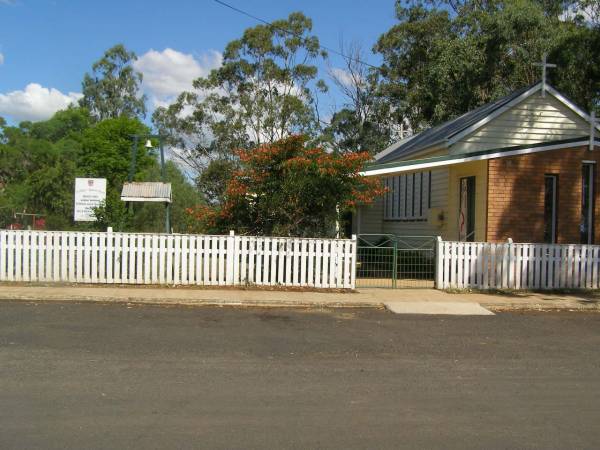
xmin=0 ymin=103 xmax=202 ymax=231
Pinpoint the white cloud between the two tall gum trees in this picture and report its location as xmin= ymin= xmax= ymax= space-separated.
xmin=133 ymin=48 xmax=223 ymax=107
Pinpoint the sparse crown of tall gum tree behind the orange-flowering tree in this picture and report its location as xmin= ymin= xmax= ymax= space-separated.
xmin=153 ymin=13 xmax=325 ymax=183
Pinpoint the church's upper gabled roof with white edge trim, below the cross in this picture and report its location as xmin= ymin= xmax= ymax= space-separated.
xmin=375 ymin=82 xmax=589 ymax=163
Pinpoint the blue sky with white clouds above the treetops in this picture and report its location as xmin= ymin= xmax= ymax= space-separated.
xmin=0 ymin=0 xmax=395 ymax=123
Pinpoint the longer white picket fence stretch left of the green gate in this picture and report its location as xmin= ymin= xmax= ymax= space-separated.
xmin=0 ymin=230 xmax=356 ymax=288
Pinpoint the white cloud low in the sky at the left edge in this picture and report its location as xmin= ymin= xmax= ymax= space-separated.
xmin=0 ymin=83 xmax=82 ymax=122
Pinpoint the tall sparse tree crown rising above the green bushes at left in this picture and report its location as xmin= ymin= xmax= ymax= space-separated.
xmin=80 ymin=44 xmax=146 ymax=120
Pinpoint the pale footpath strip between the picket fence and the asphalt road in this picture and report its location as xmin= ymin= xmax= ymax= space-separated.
xmin=0 ymin=283 xmax=600 ymax=314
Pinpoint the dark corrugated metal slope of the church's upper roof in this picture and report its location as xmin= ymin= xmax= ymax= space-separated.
xmin=377 ymin=83 xmax=539 ymax=163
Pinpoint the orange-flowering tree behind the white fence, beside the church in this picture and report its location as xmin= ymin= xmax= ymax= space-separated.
xmin=188 ymin=136 xmax=384 ymax=236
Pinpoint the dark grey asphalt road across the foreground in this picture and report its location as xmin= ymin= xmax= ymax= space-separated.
xmin=0 ymin=302 xmax=600 ymax=449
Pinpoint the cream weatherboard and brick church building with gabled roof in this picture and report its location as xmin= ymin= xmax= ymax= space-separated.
xmin=353 ymin=81 xmax=600 ymax=244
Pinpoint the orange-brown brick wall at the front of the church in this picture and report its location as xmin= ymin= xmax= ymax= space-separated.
xmin=486 ymin=147 xmax=600 ymax=243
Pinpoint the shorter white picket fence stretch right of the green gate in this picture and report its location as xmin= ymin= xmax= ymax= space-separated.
xmin=436 ymin=240 xmax=600 ymax=289
